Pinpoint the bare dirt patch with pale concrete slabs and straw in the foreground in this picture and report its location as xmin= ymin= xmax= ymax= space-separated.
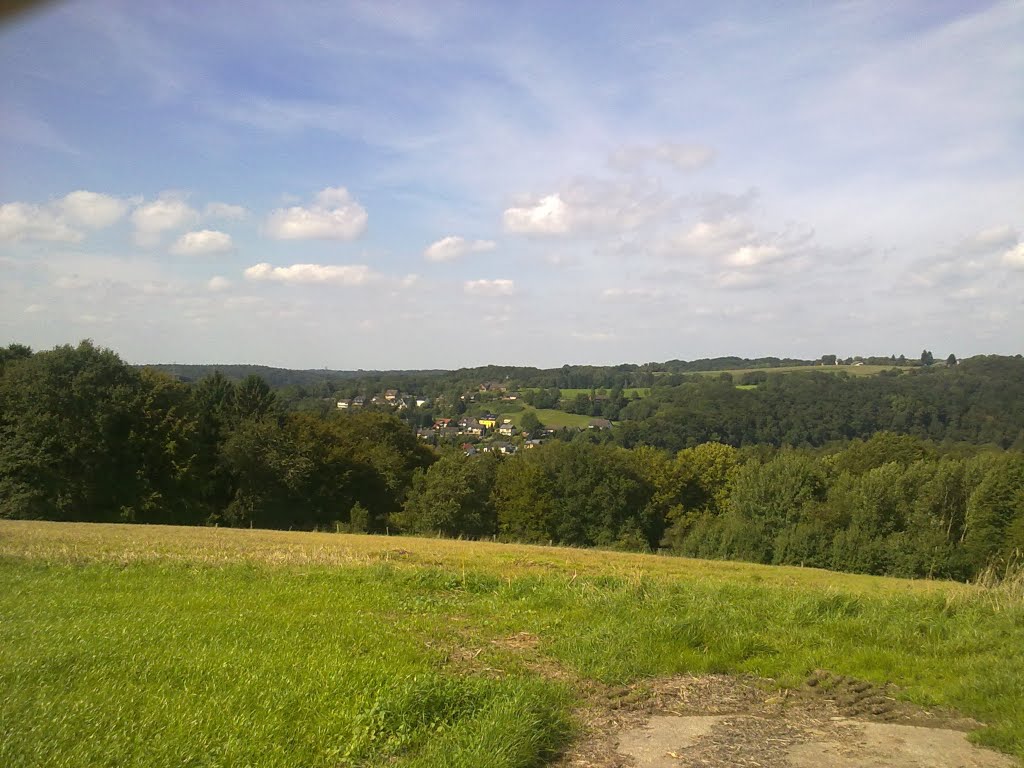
xmin=558 ymin=672 xmax=1018 ymax=768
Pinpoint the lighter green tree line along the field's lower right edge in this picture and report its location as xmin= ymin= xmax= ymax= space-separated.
xmin=396 ymin=432 xmax=1024 ymax=580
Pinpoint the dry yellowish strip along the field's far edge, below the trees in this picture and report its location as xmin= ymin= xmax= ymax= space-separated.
xmin=0 ymin=520 xmax=974 ymax=595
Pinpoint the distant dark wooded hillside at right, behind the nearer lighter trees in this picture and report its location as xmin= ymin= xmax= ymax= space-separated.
xmin=618 ymin=356 xmax=1024 ymax=451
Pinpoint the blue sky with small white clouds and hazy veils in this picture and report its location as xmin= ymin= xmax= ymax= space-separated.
xmin=0 ymin=0 xmax=1024 ymax=370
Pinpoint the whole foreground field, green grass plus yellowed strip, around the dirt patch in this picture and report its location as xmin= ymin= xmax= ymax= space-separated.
xmin=0 ymin=521 xmax=1024 ymax=767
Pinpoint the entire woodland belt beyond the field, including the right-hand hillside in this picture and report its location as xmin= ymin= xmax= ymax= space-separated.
xmin=0 ymin=342 xmax=1024 ymax=579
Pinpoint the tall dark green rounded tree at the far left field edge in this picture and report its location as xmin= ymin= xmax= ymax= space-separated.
xmin=0 ymin=341 xmax=194 ymax=522
